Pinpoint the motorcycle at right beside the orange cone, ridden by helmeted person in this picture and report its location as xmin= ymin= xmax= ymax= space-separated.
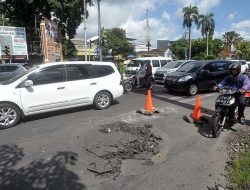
xmin=212 ymin=87 xmax=240 ymax=138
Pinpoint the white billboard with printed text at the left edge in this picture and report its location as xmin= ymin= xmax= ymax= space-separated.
xmin=0 ymin=26 xmax=28 ymax=60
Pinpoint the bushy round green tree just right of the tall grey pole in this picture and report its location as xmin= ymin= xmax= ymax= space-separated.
xmin=103 ymin=28 xmax=134 ymax=57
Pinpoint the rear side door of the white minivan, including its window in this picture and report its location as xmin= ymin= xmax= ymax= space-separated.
xmin=66 ymin=64 xmax=98 ymax=105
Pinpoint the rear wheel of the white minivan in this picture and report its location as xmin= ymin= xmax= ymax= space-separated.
xmin=94 ymin=91 xmax=112 ymax=110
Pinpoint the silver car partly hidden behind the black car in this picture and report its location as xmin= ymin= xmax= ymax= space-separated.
xmin=154 ymin=60 xmax=195 ymax=83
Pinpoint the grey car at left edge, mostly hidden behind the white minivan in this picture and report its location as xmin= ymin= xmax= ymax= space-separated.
xmin=0 ymin=63 xmax=27 ymax=82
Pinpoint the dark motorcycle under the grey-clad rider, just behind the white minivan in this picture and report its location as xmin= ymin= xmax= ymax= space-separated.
xmin=123 ymin=75 xmax=154 ymax=92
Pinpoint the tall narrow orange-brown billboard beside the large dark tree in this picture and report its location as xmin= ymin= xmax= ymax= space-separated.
xmin=40 ymin=18 xmax=62 ymax=62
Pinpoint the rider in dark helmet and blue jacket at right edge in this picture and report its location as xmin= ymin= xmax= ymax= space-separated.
xmin=214 ymin=62 xmax=250 ymax=125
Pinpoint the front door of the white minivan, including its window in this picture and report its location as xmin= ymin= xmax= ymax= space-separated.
xmin=20 ymin=65 xmax=68 ymax=114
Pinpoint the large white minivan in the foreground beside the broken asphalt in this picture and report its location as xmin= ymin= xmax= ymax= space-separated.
xmin=0 ymin=61 xmax=123 ymax=128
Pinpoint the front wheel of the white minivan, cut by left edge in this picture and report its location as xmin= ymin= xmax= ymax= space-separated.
xmin=0 ymin=103 xmax=22 ymax=129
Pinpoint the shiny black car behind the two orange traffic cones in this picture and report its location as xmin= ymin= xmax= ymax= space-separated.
xmin=164 ymin=60 xmax=232 ymax=95
